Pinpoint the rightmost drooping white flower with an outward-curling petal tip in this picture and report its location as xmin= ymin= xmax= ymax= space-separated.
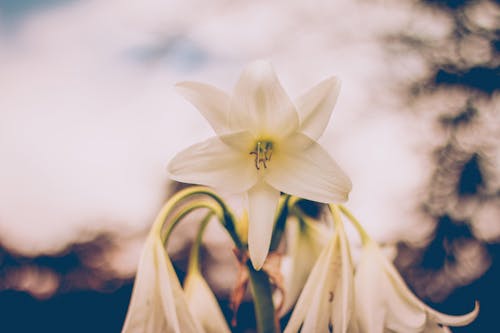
xmin=355 ymin=239 xmax=479 ymax=333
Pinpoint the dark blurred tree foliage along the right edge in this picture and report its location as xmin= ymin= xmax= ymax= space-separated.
xmin=389 ymin=0 xmax=500 ymax=332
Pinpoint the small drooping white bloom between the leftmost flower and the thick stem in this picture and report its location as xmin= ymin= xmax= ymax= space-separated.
xmin=184 ymin=272 xmax=231 ymax=333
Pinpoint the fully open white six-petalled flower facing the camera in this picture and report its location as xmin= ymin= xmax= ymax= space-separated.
xmin=168 ymin=61 xmax=351 ymax=269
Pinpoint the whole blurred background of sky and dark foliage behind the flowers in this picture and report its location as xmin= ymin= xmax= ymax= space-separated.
xmin=0 ymin=0 xmax=500 ymax=333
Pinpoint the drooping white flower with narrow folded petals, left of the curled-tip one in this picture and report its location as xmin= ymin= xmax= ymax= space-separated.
xmin=284 ymin=218 xmax=354 ymax=333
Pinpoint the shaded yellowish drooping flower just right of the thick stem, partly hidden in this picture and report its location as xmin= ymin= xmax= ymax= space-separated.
xmin=280 ymin=217 xmax=332 ymax=315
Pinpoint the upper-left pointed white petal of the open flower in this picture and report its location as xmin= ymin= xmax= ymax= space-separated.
xmin=176 ymin=82 xmax=230 ymax=134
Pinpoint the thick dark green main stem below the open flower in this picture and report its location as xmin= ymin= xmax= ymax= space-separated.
xmin=247 ymin=262 xmax=280 ymax=333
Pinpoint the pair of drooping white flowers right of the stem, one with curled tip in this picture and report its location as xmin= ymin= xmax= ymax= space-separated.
xmin=285 ymin=205 xmax=479 ymax=333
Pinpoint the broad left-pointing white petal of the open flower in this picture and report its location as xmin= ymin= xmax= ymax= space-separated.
xmin=168 ymin=133 xmax=258 ymax=193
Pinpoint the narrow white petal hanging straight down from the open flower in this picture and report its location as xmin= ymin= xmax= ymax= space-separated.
xmin=248 ymin=181 xmax=280 ymax=270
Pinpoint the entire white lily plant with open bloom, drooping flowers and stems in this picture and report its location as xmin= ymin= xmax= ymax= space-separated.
xmin=122 ymin=61 xmax=479 ymax=333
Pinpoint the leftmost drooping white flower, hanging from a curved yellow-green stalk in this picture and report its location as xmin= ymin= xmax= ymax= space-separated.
xmin=122 ymin=231 xmax=203 ymax=333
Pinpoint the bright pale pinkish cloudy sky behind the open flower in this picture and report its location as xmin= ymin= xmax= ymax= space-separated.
xmin=0 ymin=0 xmax=449 ymax=270
